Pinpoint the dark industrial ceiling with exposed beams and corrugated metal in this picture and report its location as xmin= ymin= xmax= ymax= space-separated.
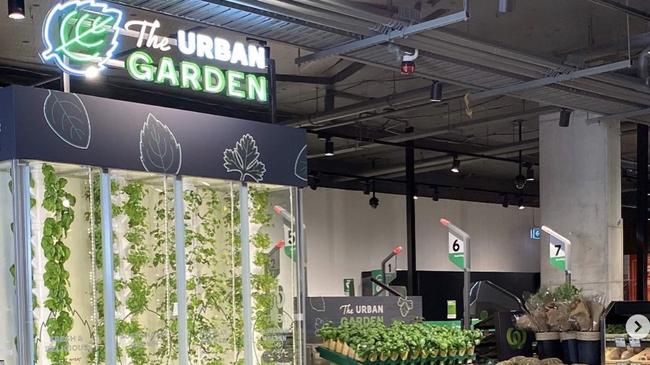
xmin=0 ymin=0 xmax=650 ymax=204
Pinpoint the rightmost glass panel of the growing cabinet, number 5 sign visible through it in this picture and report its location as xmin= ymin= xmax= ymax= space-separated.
xmin=248 ymin=184 xmax=302 ymax=364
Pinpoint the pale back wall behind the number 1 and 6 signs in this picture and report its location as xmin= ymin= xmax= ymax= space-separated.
xmin=304 ymin=188 xmax=541 ymax=296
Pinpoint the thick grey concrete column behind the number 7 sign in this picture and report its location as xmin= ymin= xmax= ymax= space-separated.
xmin=539 ymin=111 xmax=623 ymax=300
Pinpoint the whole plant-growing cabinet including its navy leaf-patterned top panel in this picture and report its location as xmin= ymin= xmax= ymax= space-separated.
xmin=0 ymin=87 xmax=307 ymax=365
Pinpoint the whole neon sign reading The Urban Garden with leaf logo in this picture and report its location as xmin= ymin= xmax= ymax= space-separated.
xmin=41 ymin=0 xmax=268 ymax=102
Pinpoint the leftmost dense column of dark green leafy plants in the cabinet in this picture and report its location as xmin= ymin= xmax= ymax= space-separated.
xmin=41 ymin=164 xmax=76 ymax=365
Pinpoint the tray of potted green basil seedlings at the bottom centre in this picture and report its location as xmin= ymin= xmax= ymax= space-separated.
xmin=318 ymin=321 xmax=483 ymax=365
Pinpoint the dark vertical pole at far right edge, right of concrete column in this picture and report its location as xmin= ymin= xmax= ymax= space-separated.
xmin=636 ymin=124 xmax=648 ymax=300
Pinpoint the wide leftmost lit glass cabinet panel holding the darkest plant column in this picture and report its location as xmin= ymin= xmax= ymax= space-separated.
xmin=29 ymin=162 xmax=103 ymax=365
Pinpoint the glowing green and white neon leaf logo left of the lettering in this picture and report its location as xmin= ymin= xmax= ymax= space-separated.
xmin=41 ymin=0 xmax=123 ymax=76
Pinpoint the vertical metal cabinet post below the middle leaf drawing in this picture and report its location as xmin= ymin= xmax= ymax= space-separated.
xmin=174 ymin=177 xmax=190 ymax=365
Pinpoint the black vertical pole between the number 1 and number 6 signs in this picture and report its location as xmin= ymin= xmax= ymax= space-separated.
xmin=404 ymin=142 xmax=419 ymax=295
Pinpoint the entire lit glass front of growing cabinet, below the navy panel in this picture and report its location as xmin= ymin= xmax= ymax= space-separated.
xmin=5 ymin=162 xmax=303 ymax=365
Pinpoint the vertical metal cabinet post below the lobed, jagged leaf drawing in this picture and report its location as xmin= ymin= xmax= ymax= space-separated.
xmin=239 ymin=183 xmax=255 ymax=365
